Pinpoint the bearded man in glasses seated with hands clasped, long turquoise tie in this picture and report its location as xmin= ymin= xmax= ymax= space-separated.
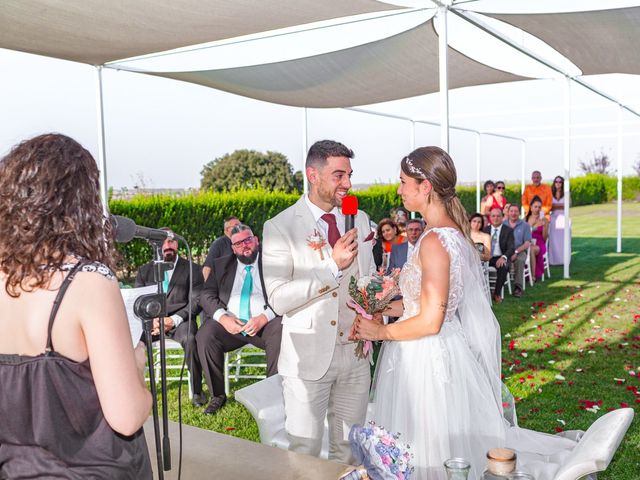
xmin=197 ymin=224 xmax=282 ymax=415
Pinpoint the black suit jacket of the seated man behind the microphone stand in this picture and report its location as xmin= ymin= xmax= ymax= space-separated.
xmin=136 ymin=257 xmax=204 ymax=321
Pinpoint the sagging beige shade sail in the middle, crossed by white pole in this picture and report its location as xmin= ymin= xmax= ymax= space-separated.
xmin=138 ymin=20 xmax=522 ymax=108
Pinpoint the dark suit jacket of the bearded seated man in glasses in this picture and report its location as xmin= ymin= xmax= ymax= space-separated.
xmin=200 ymin=252 xmax=273 ymax=318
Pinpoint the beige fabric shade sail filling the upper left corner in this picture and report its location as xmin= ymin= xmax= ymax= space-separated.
xmin=0 ymin=0 xmax=398 ymax=65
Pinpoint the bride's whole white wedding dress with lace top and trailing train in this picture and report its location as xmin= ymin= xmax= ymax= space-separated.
xmin=373 ymin=228 xmax=575 ymax=480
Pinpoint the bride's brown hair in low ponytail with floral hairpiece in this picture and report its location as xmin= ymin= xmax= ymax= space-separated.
xmin=400 ymin=147 xmax=471 ymax=241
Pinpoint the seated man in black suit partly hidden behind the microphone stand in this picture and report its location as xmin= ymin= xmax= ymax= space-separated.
xmin=136 ymin=229 xmax=207 ymax=406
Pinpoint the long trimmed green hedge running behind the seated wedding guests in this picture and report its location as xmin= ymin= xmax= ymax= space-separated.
xmin=109 ymin=174 xmax=640 ymax=278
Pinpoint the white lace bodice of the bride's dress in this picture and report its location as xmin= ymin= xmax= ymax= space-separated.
xmin=399 ymin=227 xmax=464 ymax=322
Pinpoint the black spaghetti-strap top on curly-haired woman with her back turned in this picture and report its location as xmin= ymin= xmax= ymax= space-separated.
xmin=0 ymin=262 xmax=153 ymax=480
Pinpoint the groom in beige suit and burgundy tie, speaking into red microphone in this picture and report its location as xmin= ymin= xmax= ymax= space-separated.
xmin=262 ymin=140 xmax=375 ymax=463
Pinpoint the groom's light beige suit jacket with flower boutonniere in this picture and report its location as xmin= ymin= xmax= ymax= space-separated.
xmin=262 ymin=196 xmax=375 ymax=380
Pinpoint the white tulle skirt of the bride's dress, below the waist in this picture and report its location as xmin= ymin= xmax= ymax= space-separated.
xmin=373 ymin=318 xmax=507 ymax=480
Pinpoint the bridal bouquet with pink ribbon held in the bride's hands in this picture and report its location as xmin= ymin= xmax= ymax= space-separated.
xmin=347 ymin=269 xmax=400 ymax=365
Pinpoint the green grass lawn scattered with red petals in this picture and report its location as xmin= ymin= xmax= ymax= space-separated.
xmin=156 ymin=203 xmax=640 ymax=480
